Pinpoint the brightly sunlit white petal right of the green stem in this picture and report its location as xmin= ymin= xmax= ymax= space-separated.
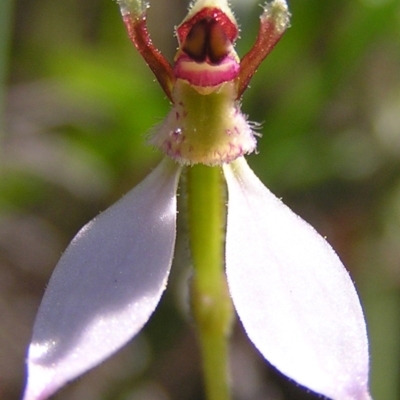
xmin=224 ymin=158 xmax=370 ymax=400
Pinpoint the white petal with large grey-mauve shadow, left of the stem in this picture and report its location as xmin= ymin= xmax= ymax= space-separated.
xmin=24 ymin=159 xmax=180 ymax=400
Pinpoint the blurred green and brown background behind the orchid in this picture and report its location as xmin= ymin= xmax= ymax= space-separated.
xmin=0 ymin=0 xmax=400 ymax=400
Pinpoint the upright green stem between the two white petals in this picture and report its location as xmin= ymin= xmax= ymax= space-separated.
xmin=187 ymin=165 xmax=233 ymax=400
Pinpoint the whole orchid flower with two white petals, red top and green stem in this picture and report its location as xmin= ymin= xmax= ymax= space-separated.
xmin=24 ymin=0 xmax=371 ymax=400
